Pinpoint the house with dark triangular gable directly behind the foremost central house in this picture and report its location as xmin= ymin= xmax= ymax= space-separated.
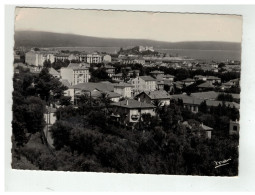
xmin=135 ymin=90 xmax=170 ymax=106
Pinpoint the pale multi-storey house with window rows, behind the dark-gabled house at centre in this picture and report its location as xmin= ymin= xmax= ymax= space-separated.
xmin=131 ymin=76 xmax=156 ymax=92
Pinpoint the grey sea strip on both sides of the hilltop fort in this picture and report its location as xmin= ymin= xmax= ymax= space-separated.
xmin=50 ymin=47 xmax=241 ymax=61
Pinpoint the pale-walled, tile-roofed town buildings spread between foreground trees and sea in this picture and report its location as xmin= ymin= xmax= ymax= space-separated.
xmin=15 ymin=46 xmax=240 ymax=139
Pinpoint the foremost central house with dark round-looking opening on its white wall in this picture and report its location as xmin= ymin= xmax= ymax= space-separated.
xmin=111 ymin=99 xmax=155 ymax=124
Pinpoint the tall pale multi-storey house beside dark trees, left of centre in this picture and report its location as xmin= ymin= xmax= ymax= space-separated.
xmin=60 ymin=63 xmax=90 ymax=85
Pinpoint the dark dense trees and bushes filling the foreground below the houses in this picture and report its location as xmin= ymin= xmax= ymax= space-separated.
xmin=12 ymin=63 xmax=239 ymax=176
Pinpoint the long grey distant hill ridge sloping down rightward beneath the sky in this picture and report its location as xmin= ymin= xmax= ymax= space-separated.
xmin=14 ymin=31 xmax=241 ymax=51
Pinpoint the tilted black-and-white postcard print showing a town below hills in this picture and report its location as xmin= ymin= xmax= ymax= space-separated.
xmin=10 ymin=7 xmax=243 ymax=177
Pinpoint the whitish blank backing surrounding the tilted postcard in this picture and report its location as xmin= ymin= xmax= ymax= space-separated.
xmin=2 ymin=5 xmax=255 ymax=191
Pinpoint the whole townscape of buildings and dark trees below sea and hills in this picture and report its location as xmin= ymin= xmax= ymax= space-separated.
xmin=12 ymin=46 xmax=241 ymax=176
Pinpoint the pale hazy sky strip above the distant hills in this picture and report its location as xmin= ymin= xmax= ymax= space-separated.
xmin=15 ymin=8 xmax=242 ymax=42
